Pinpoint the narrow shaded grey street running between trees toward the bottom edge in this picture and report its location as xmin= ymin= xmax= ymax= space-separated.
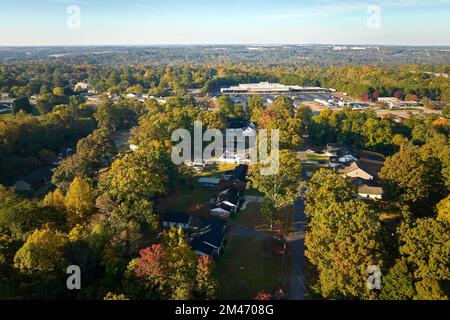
xmin=287 ymin=172 xmax=308 ymax=300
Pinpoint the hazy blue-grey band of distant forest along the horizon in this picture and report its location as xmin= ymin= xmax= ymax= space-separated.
xmin=0 ymin=44 xmax=450 ymax=66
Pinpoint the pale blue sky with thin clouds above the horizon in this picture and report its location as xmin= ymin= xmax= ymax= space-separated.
xmin=0 ymin=0 xmax=450 ymax=46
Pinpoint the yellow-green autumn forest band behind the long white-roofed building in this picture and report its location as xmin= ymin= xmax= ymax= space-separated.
xmin=0 ymin=63 xmax=450 ymax=102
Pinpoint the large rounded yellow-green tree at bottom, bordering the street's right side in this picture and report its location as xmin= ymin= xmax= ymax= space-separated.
xmin=305 ymin=200 xmax=382 ymax=299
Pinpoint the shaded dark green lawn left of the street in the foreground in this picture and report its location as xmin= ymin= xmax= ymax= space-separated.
xmin=217 ymin=236 xmax=283 ymax=300
